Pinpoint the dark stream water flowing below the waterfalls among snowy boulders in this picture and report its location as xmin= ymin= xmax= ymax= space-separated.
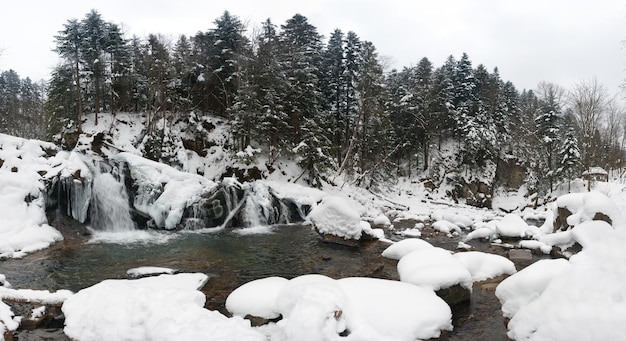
xmin=0 ymin=218 xmax=506 ymax=340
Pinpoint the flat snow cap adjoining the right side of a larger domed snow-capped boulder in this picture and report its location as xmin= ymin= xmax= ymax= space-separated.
xmin=453 ymin=251 xmax=517 ymax=282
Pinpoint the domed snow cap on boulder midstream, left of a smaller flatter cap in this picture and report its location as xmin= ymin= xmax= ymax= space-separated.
xmin=398 ymin=247 xmax=472 ymax=291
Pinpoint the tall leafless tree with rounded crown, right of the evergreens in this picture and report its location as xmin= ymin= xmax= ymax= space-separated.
xmin=569 ymin=78 xmax=610 ymax=168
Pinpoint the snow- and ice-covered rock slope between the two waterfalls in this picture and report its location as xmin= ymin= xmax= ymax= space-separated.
xmin=111 ymin=153 xmax=217 ymax=229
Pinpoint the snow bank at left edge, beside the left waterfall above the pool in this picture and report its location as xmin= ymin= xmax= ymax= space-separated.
xmin=0 ymin=134 xmax=63 ymax=258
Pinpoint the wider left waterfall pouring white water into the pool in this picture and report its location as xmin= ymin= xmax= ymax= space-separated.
xmin=90 ymin=173 xmax=135 ymax=232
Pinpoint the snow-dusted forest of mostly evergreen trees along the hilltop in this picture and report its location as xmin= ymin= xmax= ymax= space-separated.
xmin=0 ymin=10 xmax=626 ymax=191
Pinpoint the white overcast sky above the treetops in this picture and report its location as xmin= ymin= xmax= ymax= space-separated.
xmin=0 ymin=0 xmax=626 ymax=94
